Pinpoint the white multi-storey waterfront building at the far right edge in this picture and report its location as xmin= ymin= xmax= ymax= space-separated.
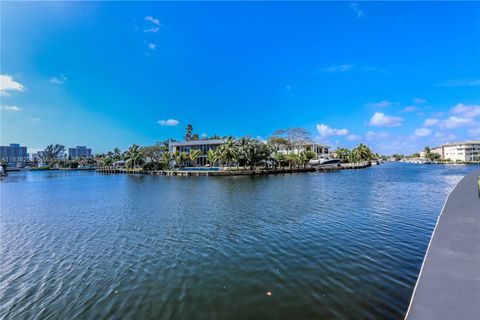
xmin=431 ymin=140 xmax=480 ymax=161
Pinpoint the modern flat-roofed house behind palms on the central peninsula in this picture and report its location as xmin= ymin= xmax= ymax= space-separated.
xmin=168 ymin=139 xmax=225 ymax=166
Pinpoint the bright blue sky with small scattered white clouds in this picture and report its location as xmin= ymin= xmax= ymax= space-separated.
xmin=0 ymin=2 xmax=480 ymax=154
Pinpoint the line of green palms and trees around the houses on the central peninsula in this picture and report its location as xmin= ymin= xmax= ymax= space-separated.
xmin=24 ymin=124 xmax=379 ymax=170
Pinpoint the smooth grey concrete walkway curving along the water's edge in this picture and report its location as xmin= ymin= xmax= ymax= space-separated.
xmin=406 ymin=170 xmax=480 ymax=320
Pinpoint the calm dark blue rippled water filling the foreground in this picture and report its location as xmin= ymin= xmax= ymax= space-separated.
xmin=0 ymin=164 xmax=475 ymax=319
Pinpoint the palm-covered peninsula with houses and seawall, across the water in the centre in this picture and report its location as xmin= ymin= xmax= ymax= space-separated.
xmin=10 ymin=125 xmax=383 ymax=176
